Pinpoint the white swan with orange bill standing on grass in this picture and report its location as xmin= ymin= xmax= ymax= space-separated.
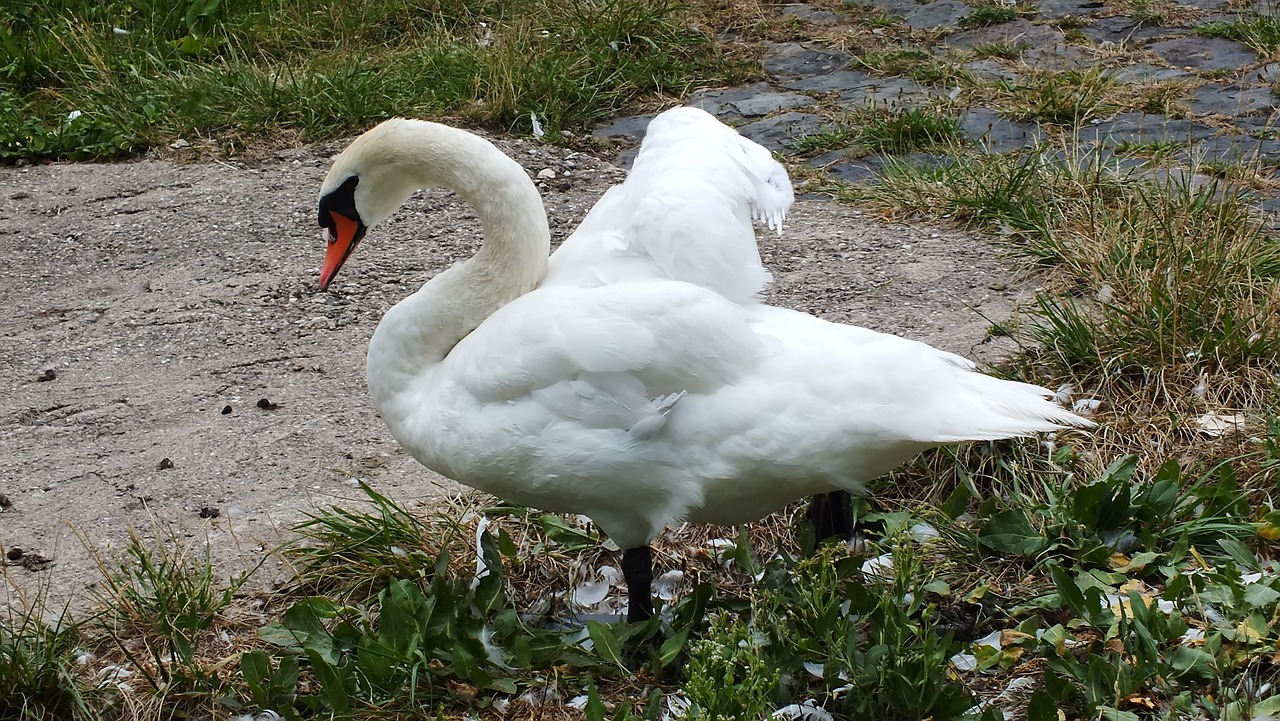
xmin=319 ymin=108 xmax=1092 ymax=620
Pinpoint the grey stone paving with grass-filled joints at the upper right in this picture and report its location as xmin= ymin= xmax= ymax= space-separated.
xmin=595 ymin=0 xmax=1280 ymax=210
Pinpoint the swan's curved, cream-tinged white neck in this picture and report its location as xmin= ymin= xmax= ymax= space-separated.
xmin=353 ymin=120 xmax=550 ymax=415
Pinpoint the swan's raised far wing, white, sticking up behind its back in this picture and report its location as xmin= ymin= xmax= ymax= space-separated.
xmin=544 ymin=108 xmax=792 ymax=304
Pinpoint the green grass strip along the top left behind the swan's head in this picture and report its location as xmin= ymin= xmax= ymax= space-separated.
xmin=0 ymin=0 xmax=742 ymax=161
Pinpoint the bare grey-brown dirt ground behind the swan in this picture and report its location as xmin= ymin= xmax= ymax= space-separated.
xmin=0 ymin=129 xmax=1024 ymax=602
